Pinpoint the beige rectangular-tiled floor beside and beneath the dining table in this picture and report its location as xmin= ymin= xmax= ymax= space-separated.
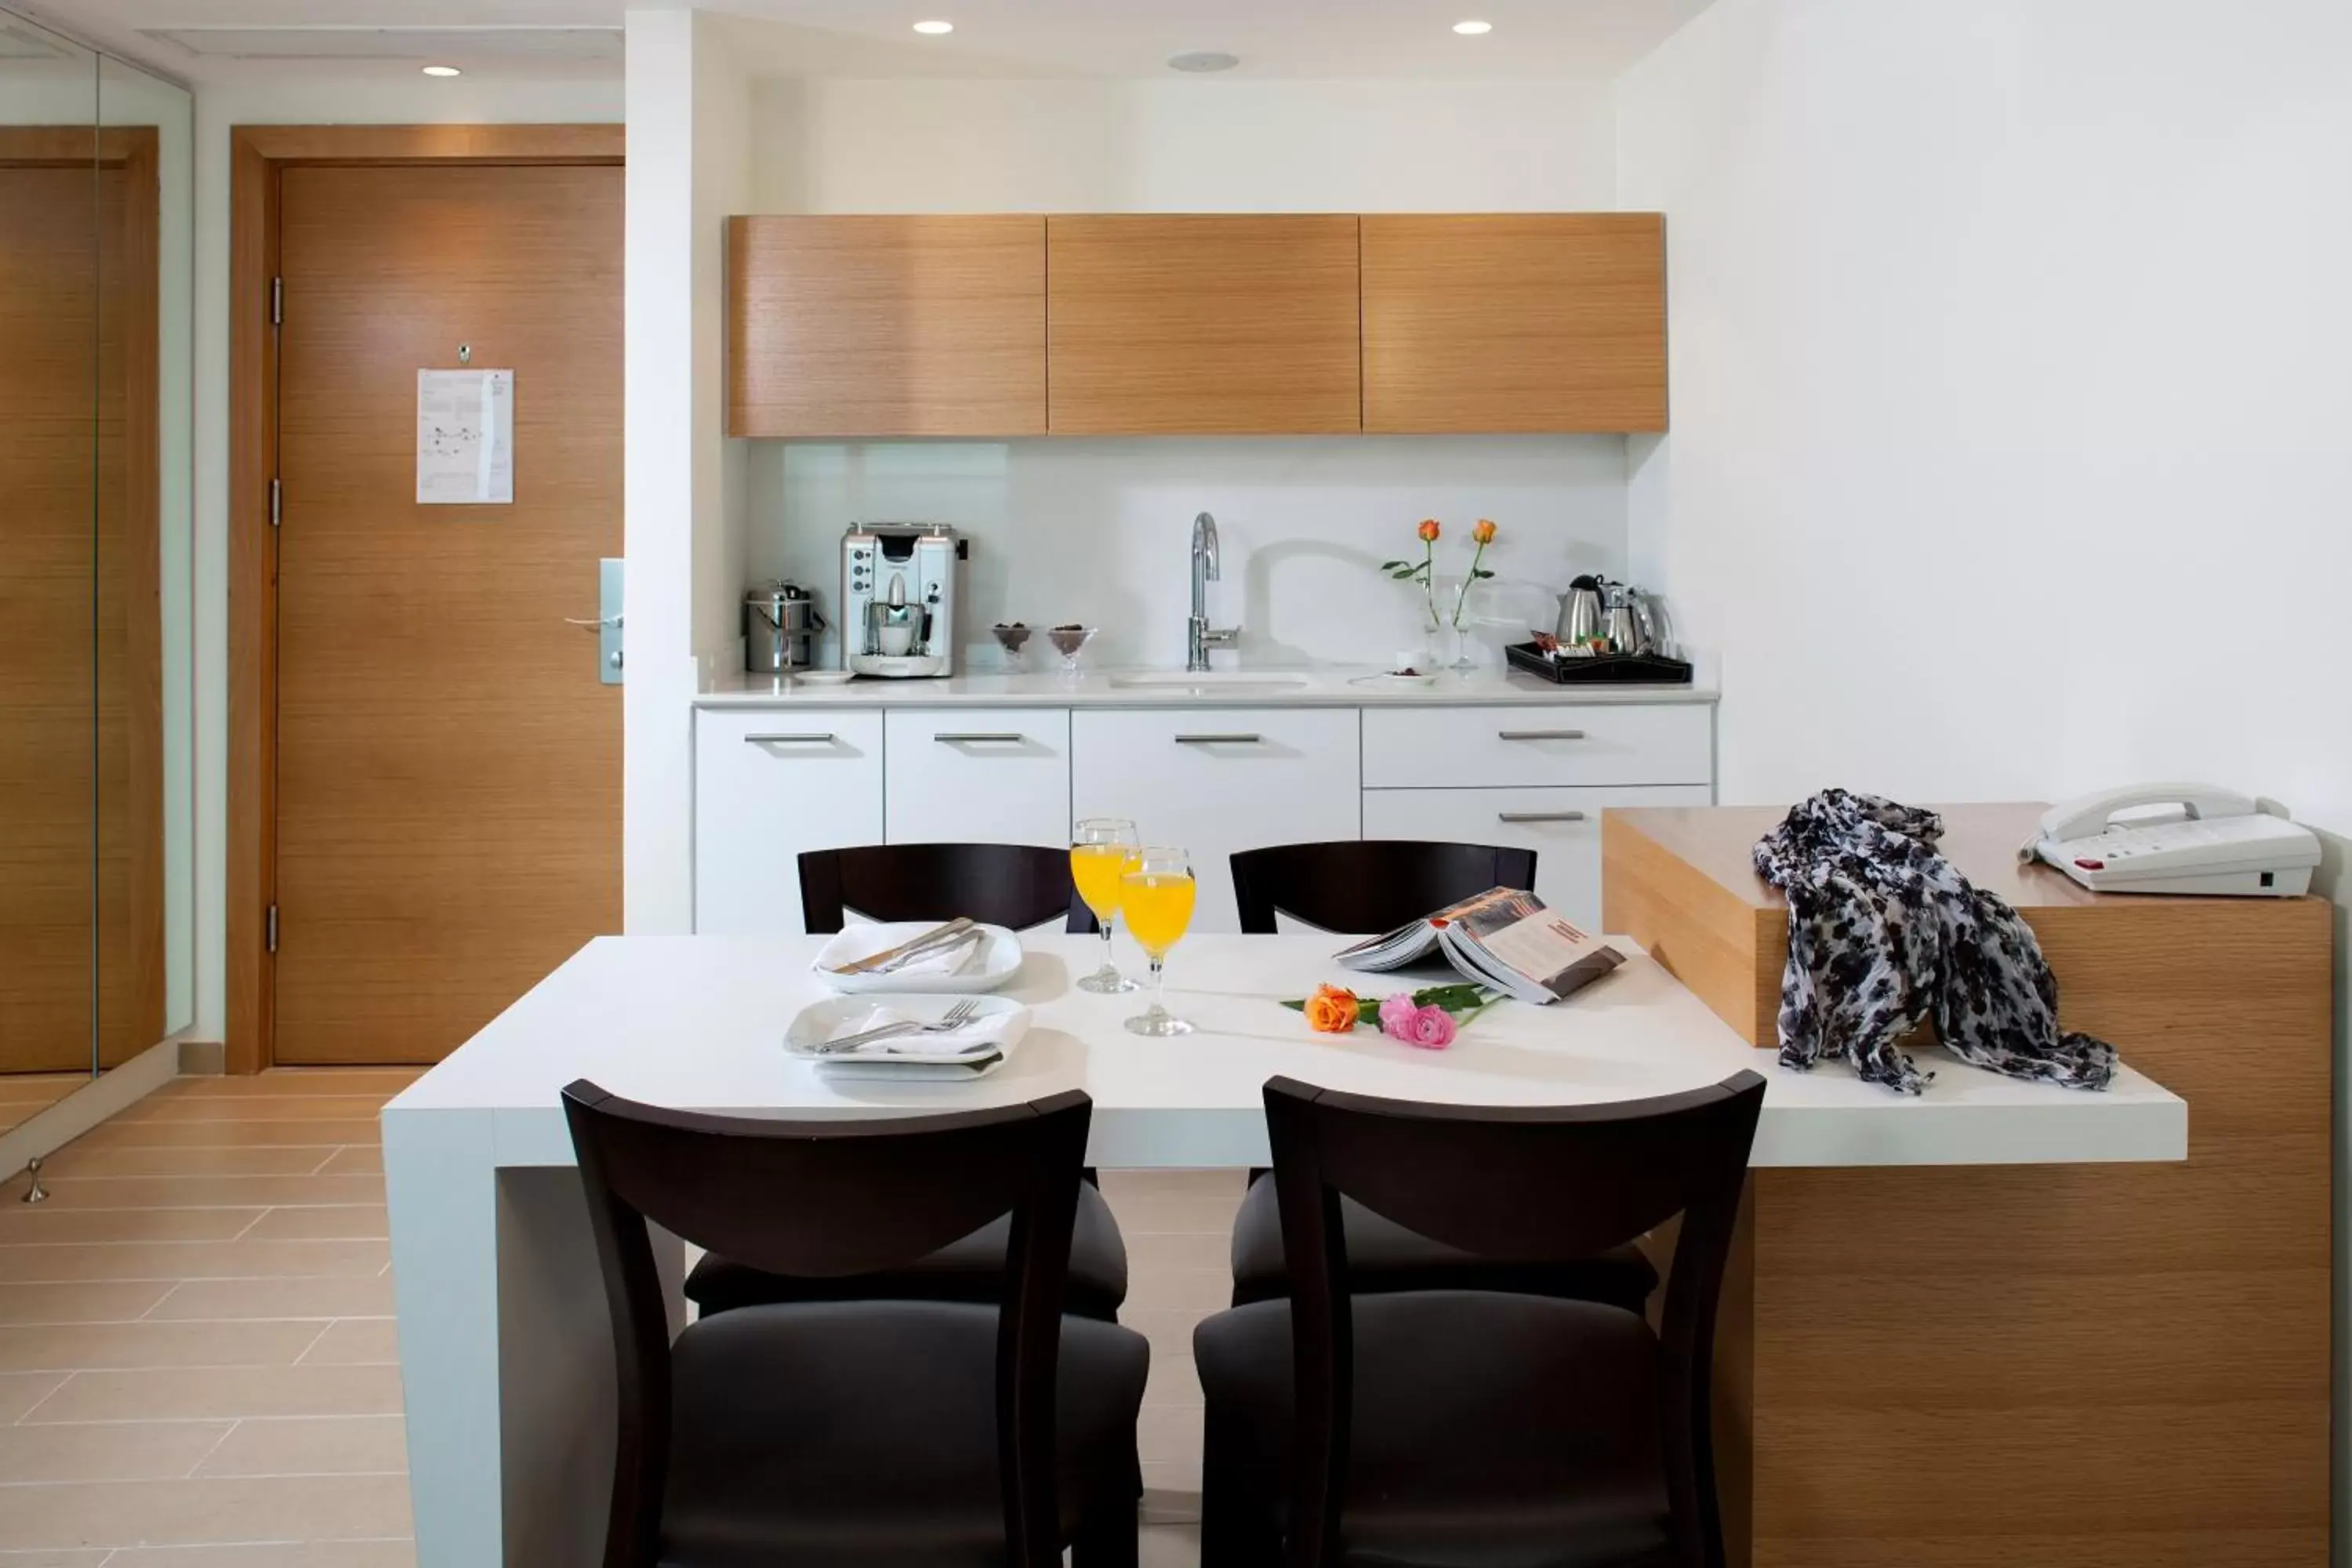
xmin=0 ymin=1069 xmax=1242 ymax=1568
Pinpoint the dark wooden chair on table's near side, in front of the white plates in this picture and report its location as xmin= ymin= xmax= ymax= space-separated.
xmin=564 ymin=1081 xmax=1150 ymax=1568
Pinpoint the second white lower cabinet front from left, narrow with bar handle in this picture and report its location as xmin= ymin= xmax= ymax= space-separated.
xmin=882 ymin=708 xmax=1070 ymax=848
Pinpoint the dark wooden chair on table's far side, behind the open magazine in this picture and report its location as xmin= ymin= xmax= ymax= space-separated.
xmin=1232 ymin=839 xmax=1658 ymax=1312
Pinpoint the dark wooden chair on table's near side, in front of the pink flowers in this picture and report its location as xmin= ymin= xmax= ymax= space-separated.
xmin=1192 ymin=1072 xmax=1764 ymax=1568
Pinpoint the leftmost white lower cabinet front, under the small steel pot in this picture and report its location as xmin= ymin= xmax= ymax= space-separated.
xmin=694 ymin=710 xmax=882 ymax=933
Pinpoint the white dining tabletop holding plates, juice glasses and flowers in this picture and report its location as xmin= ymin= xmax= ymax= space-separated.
xmin=383 ymin=933 xmax=2187 ymax=1168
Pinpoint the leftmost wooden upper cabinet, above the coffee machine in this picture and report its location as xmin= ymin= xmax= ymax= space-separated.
xmin=727 ymin=216 xmax=1044 ymax=437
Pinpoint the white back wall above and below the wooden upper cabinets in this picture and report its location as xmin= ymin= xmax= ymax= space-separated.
xmin=750 ymin=78 xmax=1625 ymax=666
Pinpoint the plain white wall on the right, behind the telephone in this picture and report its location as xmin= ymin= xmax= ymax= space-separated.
xmin=1621 ymin=0 xmax=2352 ymax=1561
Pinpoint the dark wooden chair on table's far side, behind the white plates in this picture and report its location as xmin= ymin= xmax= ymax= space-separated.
xmin=687 ymin=844 xmax=1127 ymax=1323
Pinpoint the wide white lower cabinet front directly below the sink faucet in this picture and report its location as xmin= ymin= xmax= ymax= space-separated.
xmin=1070 ymin=708 xmax=1362 ymax=931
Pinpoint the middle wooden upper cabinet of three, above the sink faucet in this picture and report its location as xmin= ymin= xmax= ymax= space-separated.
xmin=1047 ymin=214 xmax=1362 ymax=435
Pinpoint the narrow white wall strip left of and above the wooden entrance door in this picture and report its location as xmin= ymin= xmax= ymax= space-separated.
xmin=191 ymin=75 xmax=621 ymax=1039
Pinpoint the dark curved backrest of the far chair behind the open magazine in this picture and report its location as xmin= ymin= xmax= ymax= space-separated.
xmin=1232 ymin=839 xmax=1536 ymax=935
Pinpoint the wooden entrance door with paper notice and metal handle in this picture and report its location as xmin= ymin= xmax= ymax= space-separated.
xmin=275 ymin=165 xmax=621 ymax=1062
